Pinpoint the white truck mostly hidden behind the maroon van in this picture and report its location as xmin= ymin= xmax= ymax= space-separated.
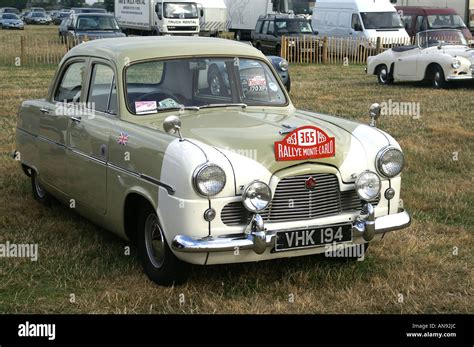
xmin=392 ymin=0 xmax=474 ymax=32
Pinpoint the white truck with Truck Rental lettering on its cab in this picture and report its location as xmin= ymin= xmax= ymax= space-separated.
xmin=115 ymin=0 xmax=200 ymax=35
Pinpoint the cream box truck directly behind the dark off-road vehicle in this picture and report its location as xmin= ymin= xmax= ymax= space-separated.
xmin=225 ymin=0 xmax=316 ymax=40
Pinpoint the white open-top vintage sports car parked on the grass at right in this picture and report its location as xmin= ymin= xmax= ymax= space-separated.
xmin=366 ymin=29 xmax=474 ymax=88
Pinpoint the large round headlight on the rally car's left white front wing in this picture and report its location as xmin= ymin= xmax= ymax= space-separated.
xmin=193 ymin=163 xmax=226 ymax=197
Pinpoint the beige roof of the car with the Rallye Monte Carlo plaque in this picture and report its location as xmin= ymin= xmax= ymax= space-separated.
xmin=64 ymin=36 xmax=265 ymax=69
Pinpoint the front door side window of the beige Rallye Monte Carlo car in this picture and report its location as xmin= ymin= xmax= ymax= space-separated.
xmin=87 ymin=64 xmax=117 ymax=114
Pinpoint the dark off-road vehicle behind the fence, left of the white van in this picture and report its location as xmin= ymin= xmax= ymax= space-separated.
xmin=252 ymin=14 xmax=313 ymax=55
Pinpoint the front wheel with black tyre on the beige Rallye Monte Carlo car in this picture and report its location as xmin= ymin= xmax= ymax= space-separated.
xmin=137 ymin=207 xmax=188 ymax=286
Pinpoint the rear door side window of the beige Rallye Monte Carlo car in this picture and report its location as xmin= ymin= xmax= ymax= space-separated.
xmin=54 ymin=61 xmax=86 ymax=103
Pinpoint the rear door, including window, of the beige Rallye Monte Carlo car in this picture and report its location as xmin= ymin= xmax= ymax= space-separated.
xmin=34 ymin=59 xmax=86 ymax=196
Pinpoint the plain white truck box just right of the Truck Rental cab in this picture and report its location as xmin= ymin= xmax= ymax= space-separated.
xmin=196 ymin=0 xmax=229 ymax=36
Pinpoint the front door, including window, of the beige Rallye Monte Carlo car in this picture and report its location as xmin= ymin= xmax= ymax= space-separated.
xmin=68 ymin=59 xmax=118 ymax=214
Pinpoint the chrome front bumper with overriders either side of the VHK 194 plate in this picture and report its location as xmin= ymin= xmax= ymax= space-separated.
xmin=172 ymin=204 xmax=411 ymax=254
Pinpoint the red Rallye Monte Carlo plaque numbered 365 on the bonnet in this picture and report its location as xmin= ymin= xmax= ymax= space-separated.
xmin=275 ymin=126 xmax=336 ymax=161
